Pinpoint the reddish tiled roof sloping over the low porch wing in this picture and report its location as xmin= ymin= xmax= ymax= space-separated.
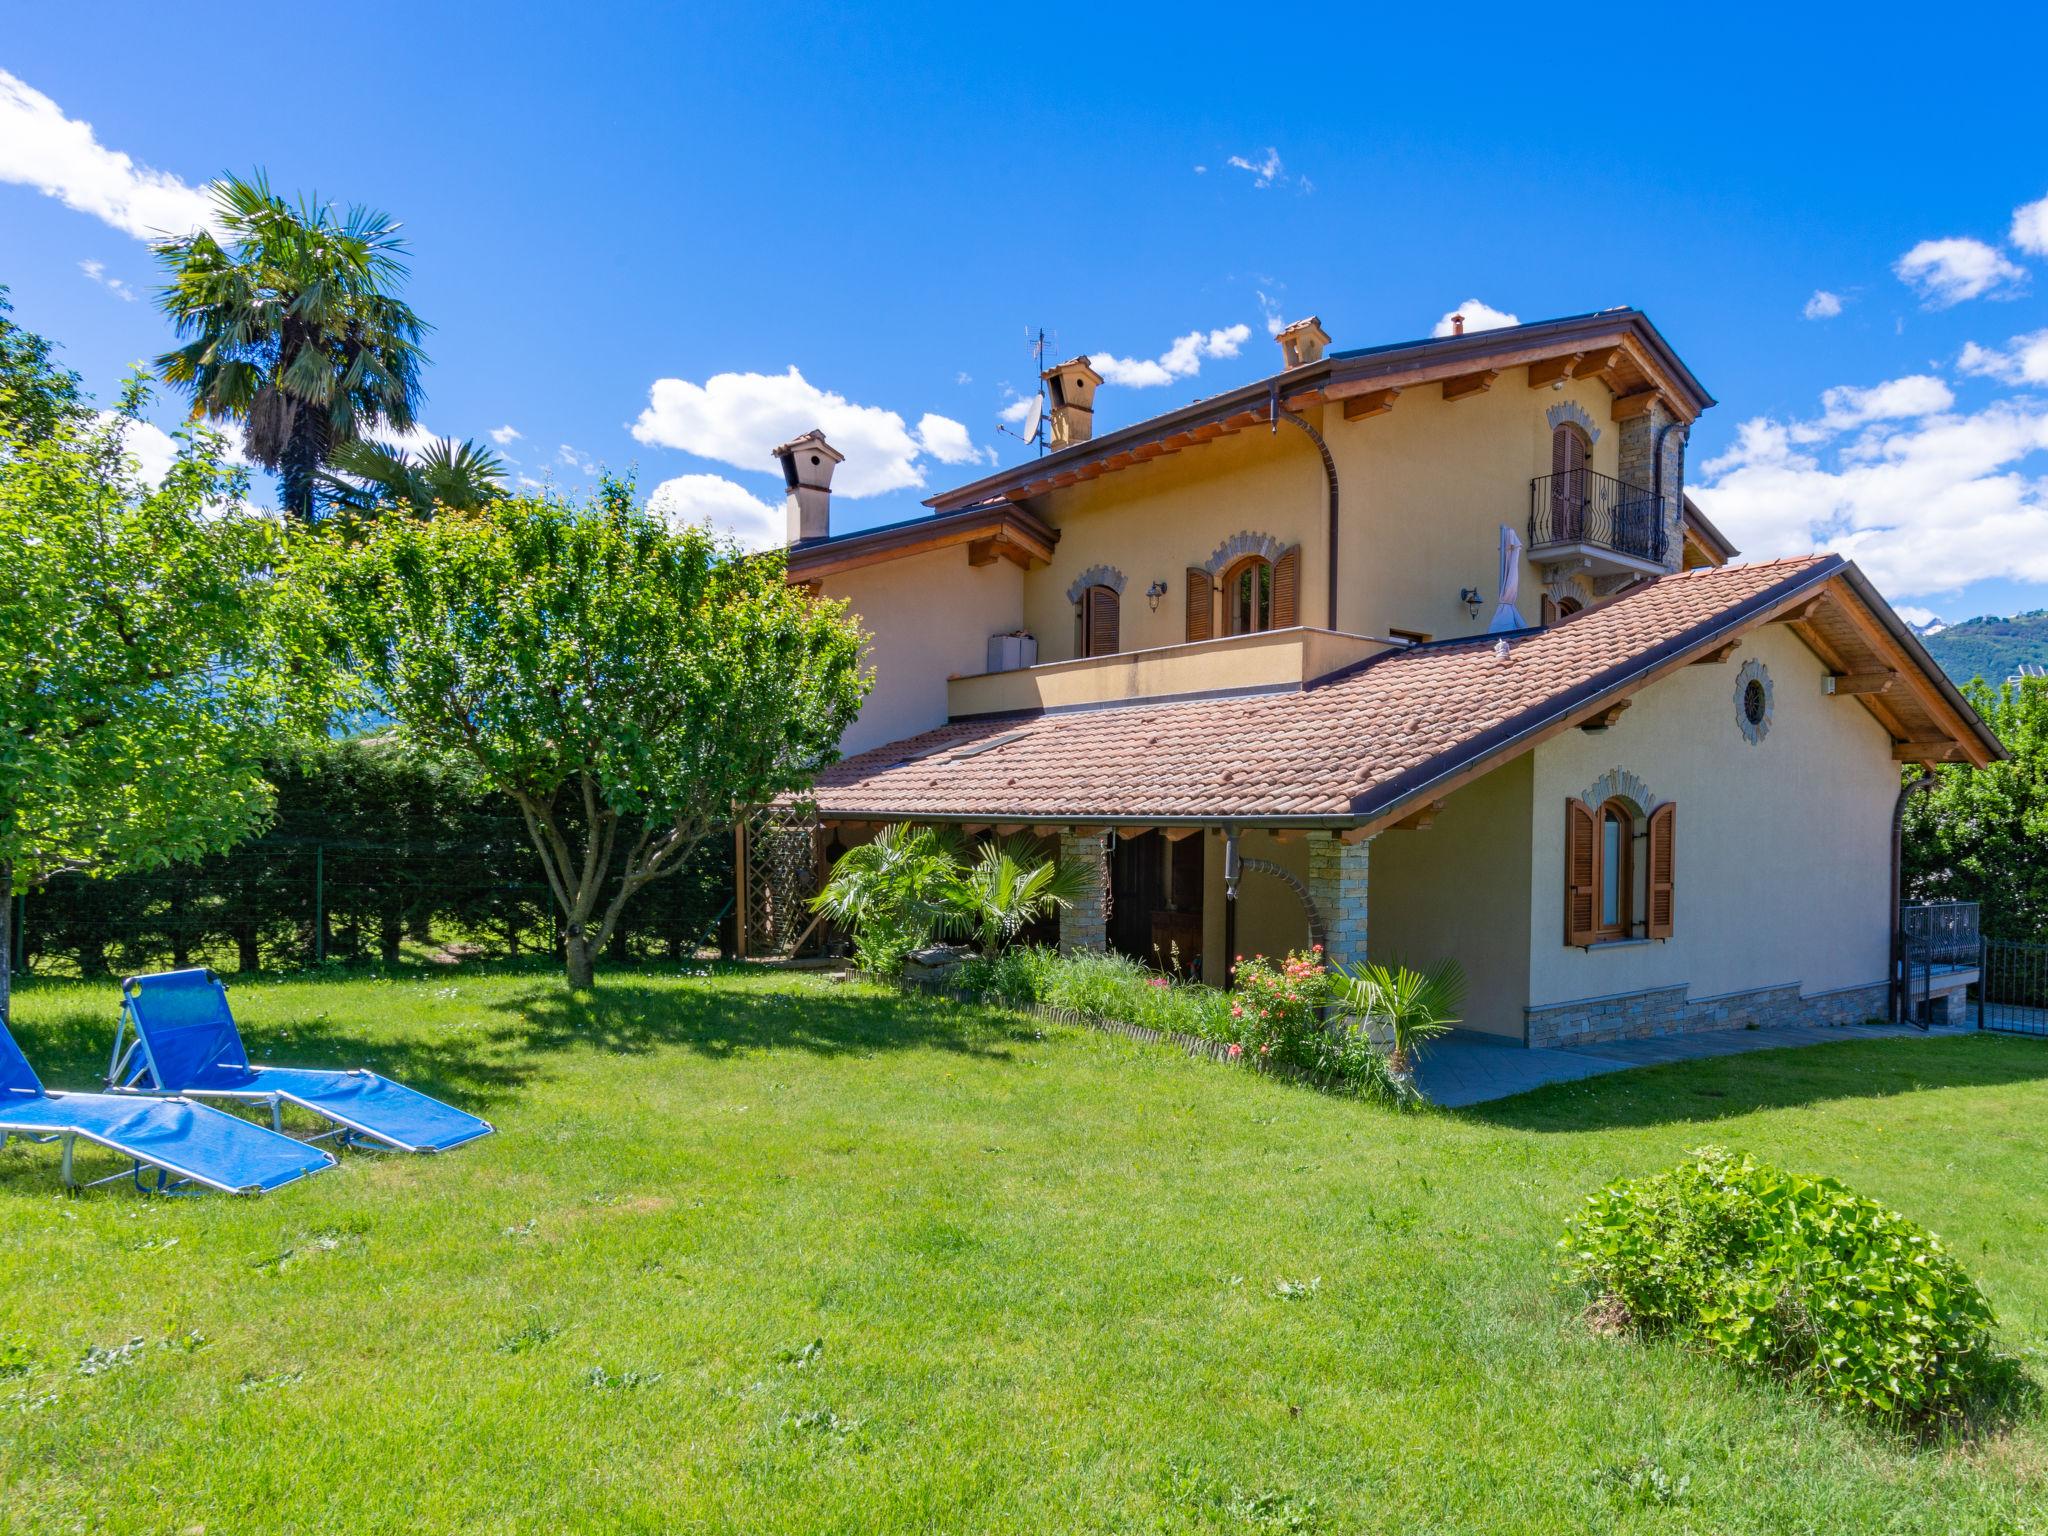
xmin=815 ymin=555 xmax=1843 ymax=823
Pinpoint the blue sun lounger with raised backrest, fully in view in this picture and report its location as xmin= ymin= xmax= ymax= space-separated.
xmin=106 ymin=971 xmax=494 ymax=1151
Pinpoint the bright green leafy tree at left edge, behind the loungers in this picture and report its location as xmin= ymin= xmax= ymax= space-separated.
xmin=0 ymin=370 xmax=324 ymax=1012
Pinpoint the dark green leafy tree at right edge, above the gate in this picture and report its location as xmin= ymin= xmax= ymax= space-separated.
xmin=1905 ymin=678 xmax=2048 ymax=944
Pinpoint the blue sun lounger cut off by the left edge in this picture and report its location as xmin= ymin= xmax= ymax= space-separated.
xmin=0 ymin=1028 xmax=334 ymax=1194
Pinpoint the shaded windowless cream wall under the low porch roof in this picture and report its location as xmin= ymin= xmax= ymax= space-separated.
xmin=1366 ymin=754 xmax=1531 ymax=1038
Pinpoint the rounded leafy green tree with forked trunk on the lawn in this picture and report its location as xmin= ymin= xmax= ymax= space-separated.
xmin=309 ymin=481 xmax=864 ymax=987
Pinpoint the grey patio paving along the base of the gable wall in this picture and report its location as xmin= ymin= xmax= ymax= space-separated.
xmin=1415 ymin=1024 xmax=1972 ymax=1108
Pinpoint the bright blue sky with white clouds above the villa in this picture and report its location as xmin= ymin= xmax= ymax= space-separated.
xmin=0 ymin=4 xmax=2048 ymax=618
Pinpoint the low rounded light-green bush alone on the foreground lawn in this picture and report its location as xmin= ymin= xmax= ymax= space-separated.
xmin=1559 ymin=1147 xmax=2011 ymax=1427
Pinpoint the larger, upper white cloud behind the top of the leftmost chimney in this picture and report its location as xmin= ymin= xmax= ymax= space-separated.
xmin=633 ymin=367 xmax=942 ymax=498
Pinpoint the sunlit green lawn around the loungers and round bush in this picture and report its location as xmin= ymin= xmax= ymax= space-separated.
xmin=0 ymin=973 xmax=2048 ymax=1536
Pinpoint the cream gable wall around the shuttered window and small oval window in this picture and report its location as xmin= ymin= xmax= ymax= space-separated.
xmin=1530 ymin=625 xmax=1898 ymax=1006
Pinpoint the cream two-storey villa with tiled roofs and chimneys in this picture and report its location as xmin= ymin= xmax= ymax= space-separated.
xmin=741 ymin=309 xmax=2001 ymax=1044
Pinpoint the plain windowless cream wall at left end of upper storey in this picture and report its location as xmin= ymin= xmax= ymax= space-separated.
xmin=823 ymin=545 xmax=1024 ymax=756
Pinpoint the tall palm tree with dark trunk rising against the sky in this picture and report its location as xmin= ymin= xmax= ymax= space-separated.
xmin=156 ymin=172 xmax=426 ymax=520
